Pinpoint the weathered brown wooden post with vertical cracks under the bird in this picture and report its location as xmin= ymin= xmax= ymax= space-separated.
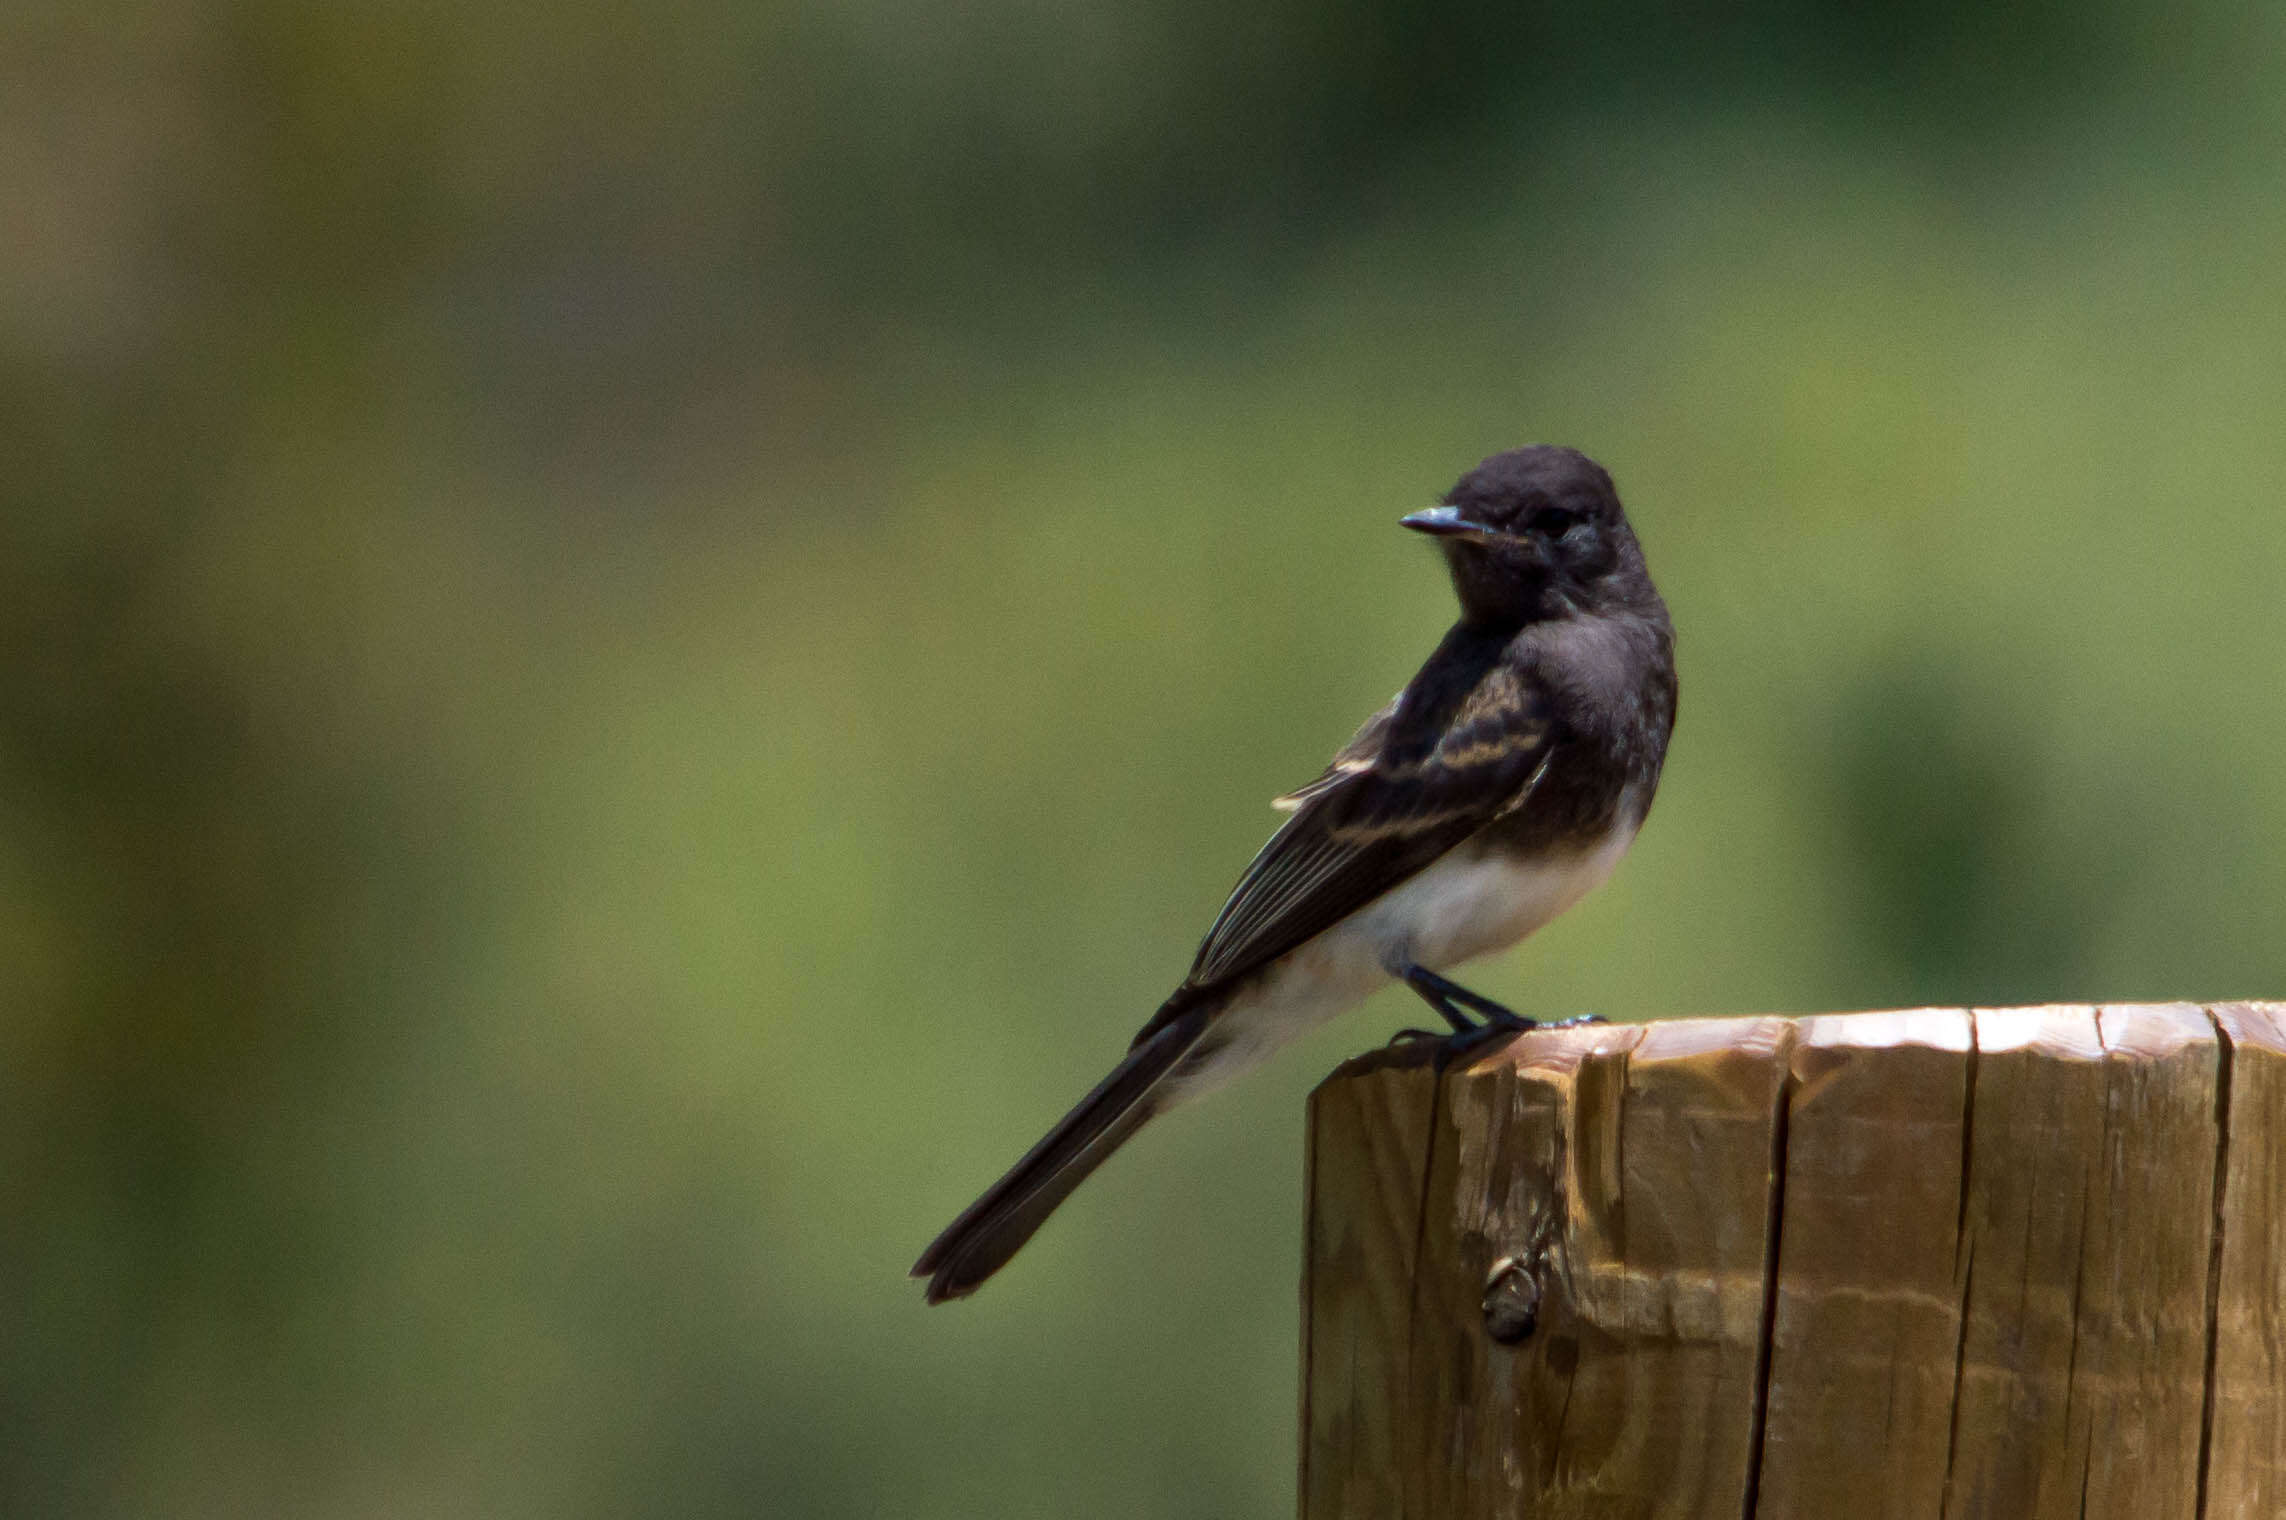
xmin=1301 ymin=1003 xmax=2286 ymax=1520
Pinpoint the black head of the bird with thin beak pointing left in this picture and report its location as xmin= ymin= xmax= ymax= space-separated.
xmin=1399 ymin=443 xmax=1650 ymax=622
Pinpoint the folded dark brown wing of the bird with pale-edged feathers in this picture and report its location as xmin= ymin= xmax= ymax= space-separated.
xmin=1184 ymin=640 xmax=1554 ymax=987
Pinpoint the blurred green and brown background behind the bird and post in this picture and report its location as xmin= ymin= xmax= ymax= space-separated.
xmin=13 ymin=0 xmax=2286 ymax=1520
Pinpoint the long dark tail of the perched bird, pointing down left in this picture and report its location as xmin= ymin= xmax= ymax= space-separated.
xmin=912 ymin=1008 xmax=1214 ymax=1303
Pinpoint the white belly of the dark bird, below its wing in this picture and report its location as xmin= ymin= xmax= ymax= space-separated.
xmin=1170 ymin=809 xmax=1637 ymax=1099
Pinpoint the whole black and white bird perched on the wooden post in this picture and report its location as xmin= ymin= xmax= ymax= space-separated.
xmin=912 ymin=446 xmax=1676 ymax=1303
